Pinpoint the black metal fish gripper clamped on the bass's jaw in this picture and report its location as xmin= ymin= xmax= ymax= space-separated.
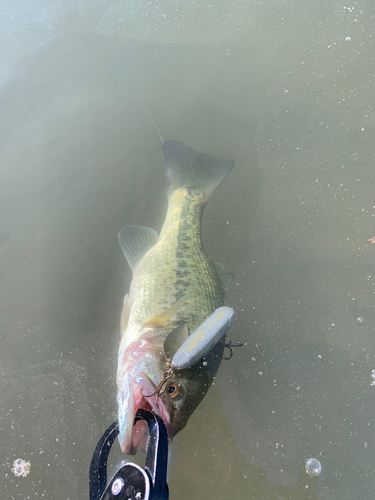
xmin=90 ymin=409 xmax=169 ymax=500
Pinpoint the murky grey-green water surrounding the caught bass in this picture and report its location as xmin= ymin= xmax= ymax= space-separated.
xmin=0 ymin=0 xmax=375 ymax=500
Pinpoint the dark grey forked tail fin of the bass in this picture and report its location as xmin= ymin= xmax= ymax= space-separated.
xmin=163 ymin=140 xmax=234 ymax=202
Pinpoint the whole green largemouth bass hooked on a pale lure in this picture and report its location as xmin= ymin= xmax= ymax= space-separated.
xmin=117 ymin=140 xmax=234 ymax=454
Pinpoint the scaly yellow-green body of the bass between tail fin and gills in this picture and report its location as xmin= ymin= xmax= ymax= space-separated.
xmin=129 ymin=190 xmax=224 ymax=332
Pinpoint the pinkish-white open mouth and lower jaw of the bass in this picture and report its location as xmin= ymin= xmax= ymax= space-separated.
xmin=117 ymin=372 xmax=174 ymax=455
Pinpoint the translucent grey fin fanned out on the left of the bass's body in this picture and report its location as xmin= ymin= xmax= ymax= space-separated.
xmin=118 ymin=226 xmax=159 ymax=271
